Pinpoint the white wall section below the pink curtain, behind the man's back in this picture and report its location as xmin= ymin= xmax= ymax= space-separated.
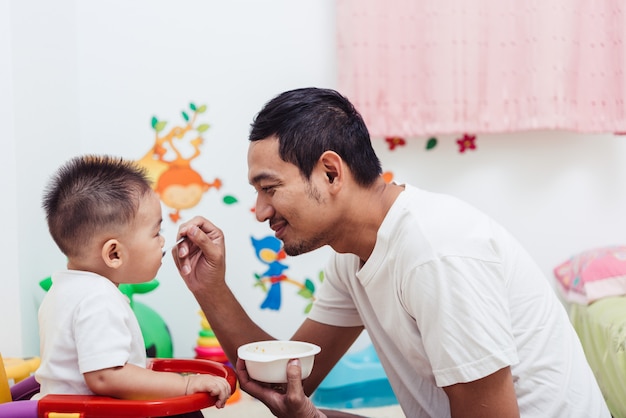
xmin=376 ymin=132 xmax=626 ymax=279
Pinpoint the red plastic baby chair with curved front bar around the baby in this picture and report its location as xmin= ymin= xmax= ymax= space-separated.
xmin=0 ymin=359 xmax=237 ymax=418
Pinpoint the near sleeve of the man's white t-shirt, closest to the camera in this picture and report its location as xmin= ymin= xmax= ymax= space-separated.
xmin=402 ymin=257 xmax=518 ymax=387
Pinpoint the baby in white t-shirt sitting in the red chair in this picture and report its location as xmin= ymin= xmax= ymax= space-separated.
xmin=35 ymin=156 xmax=230 ymax=408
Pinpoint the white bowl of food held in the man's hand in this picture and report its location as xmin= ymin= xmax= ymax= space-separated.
xmin=237 ymin=340 xmax=320 ymax=383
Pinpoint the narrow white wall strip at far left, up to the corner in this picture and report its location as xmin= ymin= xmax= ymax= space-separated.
xmin=0 ymin=0 xmax=80 ymax=355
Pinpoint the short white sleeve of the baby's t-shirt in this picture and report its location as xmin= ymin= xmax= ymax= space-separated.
xmin=74 ymin=294 xmax=132 ymax=373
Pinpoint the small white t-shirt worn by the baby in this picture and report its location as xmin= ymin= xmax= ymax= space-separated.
xmin=35 ymin=270 xmax=146 ymax=397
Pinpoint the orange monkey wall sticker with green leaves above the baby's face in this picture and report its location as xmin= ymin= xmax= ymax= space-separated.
xmin=137 ymin=103 xmax=222 ymax=223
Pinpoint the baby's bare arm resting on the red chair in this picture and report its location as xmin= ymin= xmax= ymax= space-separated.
xmin=83 ymin=364 xmax=231 ymax=408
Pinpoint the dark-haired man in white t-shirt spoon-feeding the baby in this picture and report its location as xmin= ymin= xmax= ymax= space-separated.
xmin=174 ymin=88 xmax=610 ymax=418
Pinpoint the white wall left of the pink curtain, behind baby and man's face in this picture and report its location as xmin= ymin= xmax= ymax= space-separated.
xmin=0 ymin=0 xmax=336 ymax=356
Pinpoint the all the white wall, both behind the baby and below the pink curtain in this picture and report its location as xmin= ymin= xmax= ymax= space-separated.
xmin=0 ymin=0 xmax=626 ymax=357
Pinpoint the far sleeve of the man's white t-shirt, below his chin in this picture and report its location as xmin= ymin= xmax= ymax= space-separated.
xmin=309 ymin=254 xmax=363 ymax=327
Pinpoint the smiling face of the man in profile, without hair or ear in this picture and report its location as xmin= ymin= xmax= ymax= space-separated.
xmin=248 ymin=138 xmax=328 ymax=256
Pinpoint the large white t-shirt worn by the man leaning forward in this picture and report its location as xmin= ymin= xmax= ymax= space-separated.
xmin=309 ymin=185 xmax=610 ymax=418
